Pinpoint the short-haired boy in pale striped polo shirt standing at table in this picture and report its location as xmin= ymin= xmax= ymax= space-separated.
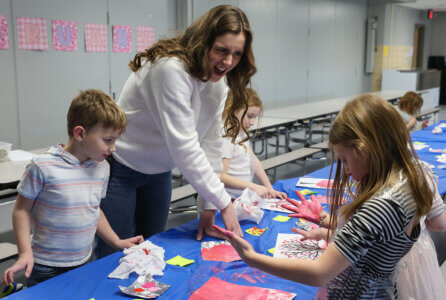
xmin=3 ymin=90 xmax=143 ymax=286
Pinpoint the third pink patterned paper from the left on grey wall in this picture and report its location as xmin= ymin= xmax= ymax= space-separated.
xmin=53 ymin=20 xmax=77 ymax=51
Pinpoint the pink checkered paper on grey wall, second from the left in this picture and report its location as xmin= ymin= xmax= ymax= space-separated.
xmin=17 ymin=17 xmax=48 ymax=50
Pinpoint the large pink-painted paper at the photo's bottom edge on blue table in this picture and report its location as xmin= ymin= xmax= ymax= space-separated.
xmin=189 ymin=276 xmax=296 ymax=300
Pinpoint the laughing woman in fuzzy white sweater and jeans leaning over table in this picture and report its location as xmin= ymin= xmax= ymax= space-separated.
xmin=96 ymin=5 xmax=256 ymax=257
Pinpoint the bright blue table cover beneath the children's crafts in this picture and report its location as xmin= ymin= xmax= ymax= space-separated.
xmin=5 ymin=121 xmax=446 ymax=300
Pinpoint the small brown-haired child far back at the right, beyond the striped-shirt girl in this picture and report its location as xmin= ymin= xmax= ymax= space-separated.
xmin=397 ymin=92 xmax=429 ymax=132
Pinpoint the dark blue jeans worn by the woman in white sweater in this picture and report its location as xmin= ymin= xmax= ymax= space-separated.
xmin=95 ymin=159 xmax=172 ymax=259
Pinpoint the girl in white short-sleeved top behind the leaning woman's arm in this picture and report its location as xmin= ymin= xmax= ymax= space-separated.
xmin=220 ymin=88 xmax=286 ymax=199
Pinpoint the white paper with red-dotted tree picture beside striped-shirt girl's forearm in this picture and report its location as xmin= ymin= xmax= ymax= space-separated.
xmin=273 ymin=233 xmax=325 ymax=260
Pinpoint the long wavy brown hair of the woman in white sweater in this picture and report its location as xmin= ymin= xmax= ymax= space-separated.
xmin=129 ymin=5 xmax=257 ymax=139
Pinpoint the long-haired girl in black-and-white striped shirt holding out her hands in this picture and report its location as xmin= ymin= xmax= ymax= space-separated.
xmin=222 ymin=95 xmax=433 ymax=299
